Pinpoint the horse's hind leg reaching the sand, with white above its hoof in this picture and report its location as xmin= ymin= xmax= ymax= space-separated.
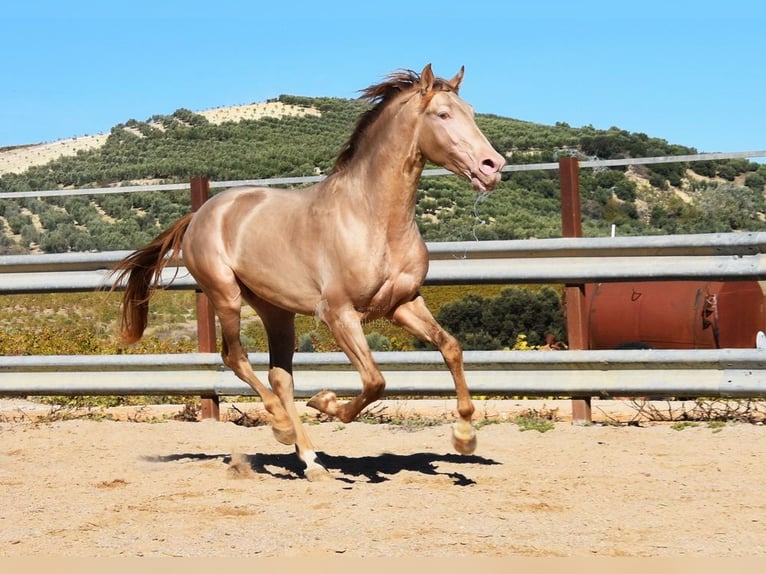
xmin=243 ymin=291 xmax=331 ymax=481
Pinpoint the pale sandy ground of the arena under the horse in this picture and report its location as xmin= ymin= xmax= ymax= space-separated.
xmin=0 ymin=401 xmax=766 ymax=558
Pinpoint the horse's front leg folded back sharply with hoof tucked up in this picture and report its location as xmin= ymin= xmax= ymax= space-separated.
xmin=307 ymin=307 xmax=386 ymax=422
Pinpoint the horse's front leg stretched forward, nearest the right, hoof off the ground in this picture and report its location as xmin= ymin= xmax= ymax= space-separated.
xmin=388 ymin=295 xmax=476 ymax=454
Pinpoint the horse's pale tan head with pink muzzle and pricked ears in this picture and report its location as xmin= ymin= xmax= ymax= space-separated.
xmin=413 ymin=64 xmax=505 ymax=191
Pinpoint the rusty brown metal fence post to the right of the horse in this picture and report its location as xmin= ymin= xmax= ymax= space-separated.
xmin=559 ymin=157 xmax=593 ymax=424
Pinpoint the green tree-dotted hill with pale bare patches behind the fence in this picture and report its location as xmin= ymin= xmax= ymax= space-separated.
xmin=0 ymin=95 xmax=766 ymax=253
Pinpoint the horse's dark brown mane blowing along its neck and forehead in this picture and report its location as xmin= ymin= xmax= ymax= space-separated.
xmin=331 ymin=70 xmax=451 ymax=173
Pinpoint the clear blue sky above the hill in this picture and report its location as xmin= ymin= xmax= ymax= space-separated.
xmin=0 ymin=0 xmax=766 ymax=156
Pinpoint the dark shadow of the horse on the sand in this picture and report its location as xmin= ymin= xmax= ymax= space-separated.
xmin=143 ymin=452 xmax=502 ymax=486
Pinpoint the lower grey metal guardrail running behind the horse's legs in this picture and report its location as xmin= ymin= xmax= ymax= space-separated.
xmin=0 ymin=349 xmax=766 ymax=398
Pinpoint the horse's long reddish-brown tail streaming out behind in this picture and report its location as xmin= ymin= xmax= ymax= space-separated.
xmin=112 ymin=213 xmax=194 ymax=343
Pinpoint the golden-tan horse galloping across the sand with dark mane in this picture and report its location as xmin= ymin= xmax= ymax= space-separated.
xmin=114 ymin=64 xmax=505 ymax=480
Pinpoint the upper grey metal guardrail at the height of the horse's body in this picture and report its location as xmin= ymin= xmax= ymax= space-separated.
xmin=0 ymin=232 xmax=766 ymax=294
